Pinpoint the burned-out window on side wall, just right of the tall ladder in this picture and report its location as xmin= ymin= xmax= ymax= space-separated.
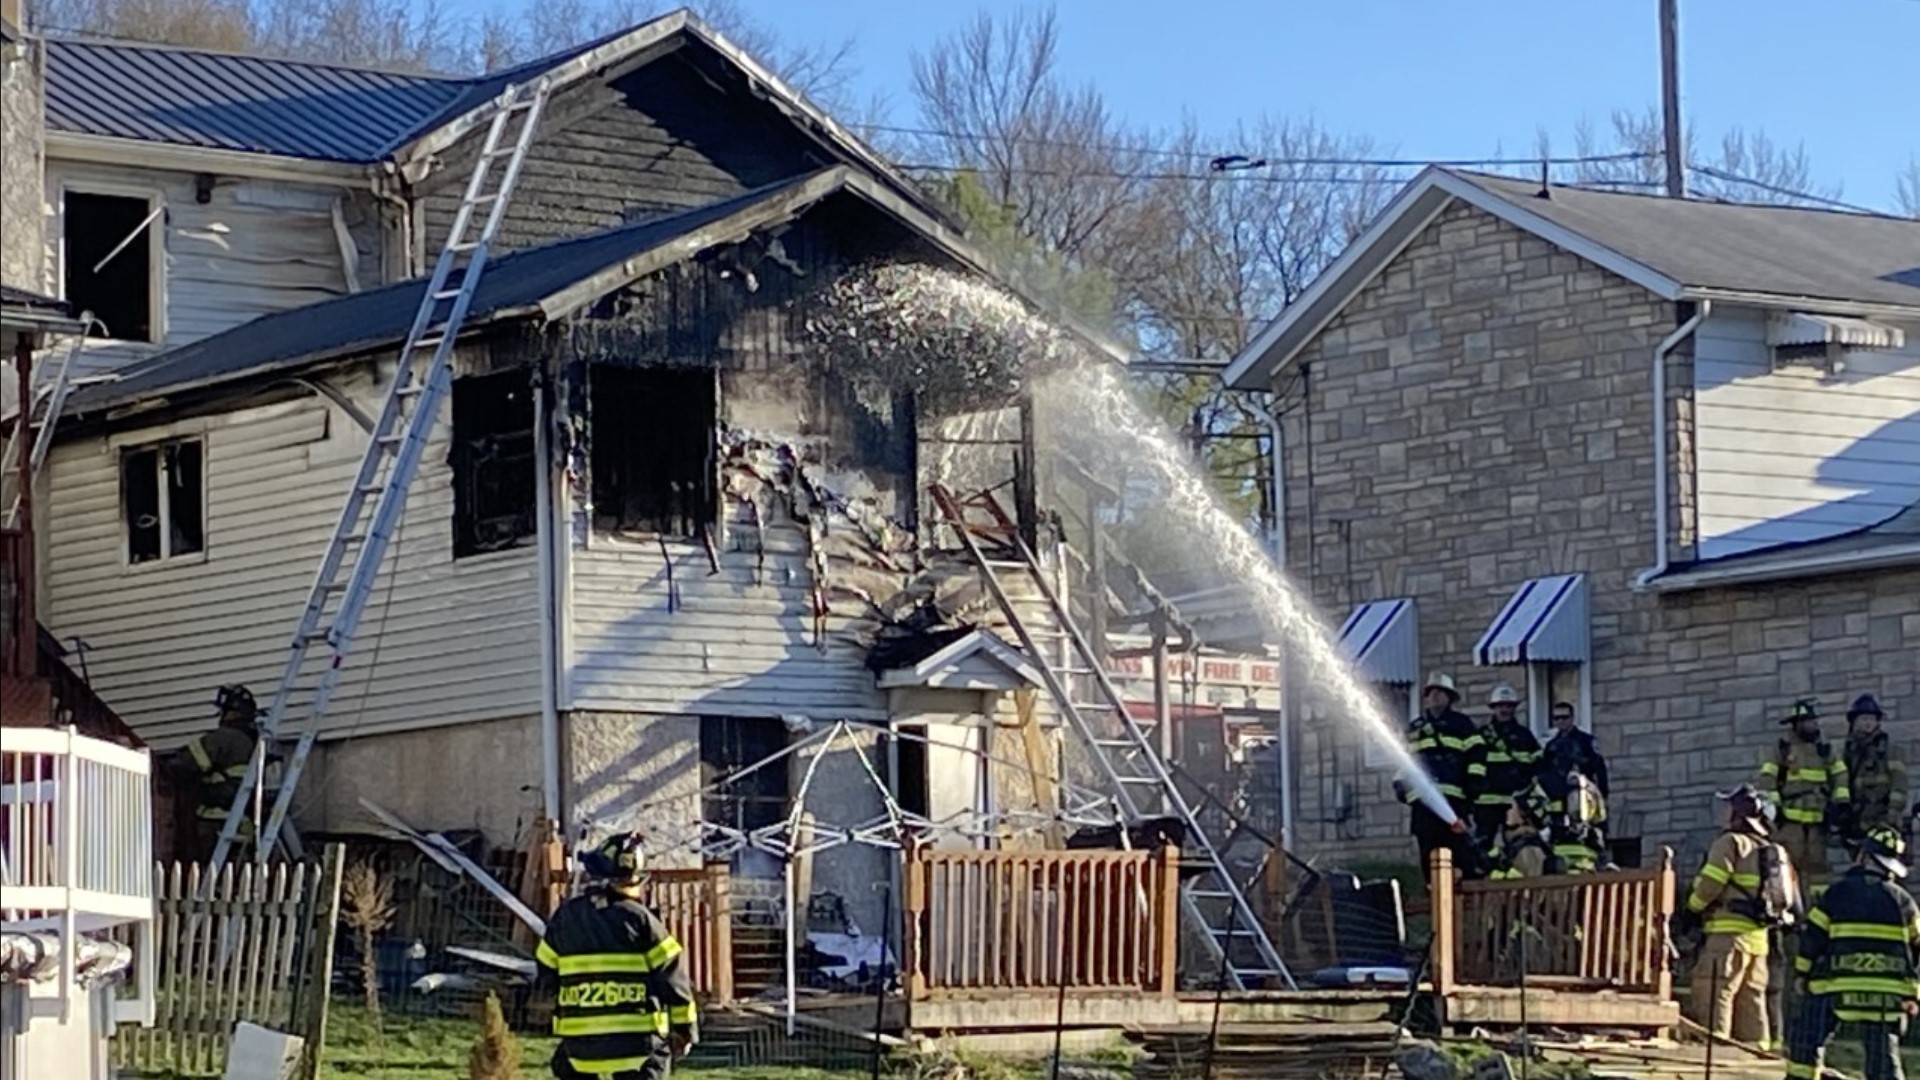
xmin=447 ymin=369 xmax=538 ymax=559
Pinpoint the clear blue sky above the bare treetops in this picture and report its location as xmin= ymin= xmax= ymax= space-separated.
xmin=698 ymin=0 xmax=1920 ymax=208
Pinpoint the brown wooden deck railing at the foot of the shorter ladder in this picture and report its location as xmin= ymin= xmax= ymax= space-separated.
xmin=902 ymin=847 xmax=1179 ymax=999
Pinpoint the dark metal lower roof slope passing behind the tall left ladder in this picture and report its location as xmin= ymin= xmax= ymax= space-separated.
xmin=67 ymin=169 xmax=825 ymax=413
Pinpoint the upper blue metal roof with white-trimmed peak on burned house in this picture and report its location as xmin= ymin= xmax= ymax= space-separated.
xmin=46 ymin=10 xmax=952 ymax=225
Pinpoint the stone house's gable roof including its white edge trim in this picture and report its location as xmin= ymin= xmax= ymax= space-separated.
xmin=1223 ymin=165 xmax=1920 ymax=390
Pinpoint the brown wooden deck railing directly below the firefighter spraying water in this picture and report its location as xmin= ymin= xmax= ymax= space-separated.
xmin=1432 ymin=849 xmax=1674 ymax=1001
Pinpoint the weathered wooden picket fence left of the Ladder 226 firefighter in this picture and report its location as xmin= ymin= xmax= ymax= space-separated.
xmin=113 ymin=849 xmax=340 ymax=1076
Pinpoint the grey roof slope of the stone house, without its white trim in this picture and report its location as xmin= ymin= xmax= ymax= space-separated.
xmin=1455 ymin=173 xmax=1920 ymax=307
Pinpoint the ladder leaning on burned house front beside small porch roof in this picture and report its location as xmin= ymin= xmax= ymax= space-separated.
xmin=931 ymin=484 xmax=1298 ymax=990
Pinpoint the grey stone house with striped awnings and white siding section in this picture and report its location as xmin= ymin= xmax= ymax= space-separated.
xmin=1227 ymin=169 xmax=1920 ymax=876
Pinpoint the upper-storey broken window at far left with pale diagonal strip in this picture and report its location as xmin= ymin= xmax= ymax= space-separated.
xmin=61 ymin=190 xmax=159 ymax=342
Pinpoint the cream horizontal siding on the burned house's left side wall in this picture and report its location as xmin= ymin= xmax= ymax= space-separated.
xmin=42 ymin=357 xmax=540 ymax=742
